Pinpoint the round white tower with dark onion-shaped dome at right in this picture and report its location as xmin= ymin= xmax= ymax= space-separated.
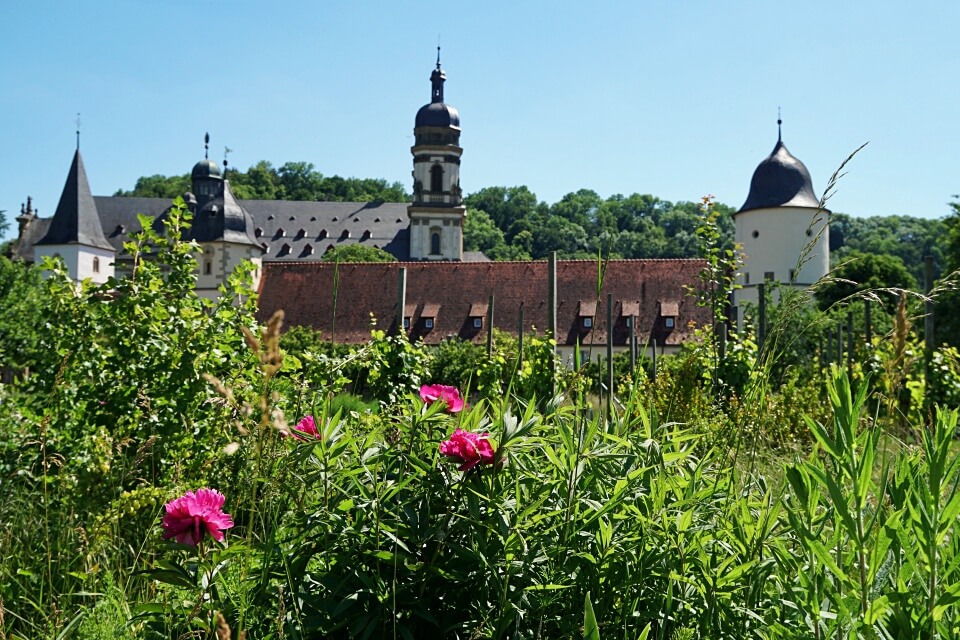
xmin=733 ymin=120 xmax=830 ymax=307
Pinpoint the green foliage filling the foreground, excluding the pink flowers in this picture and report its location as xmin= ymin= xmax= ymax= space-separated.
xmin=7 ymin=201 xmax=960 ymax=640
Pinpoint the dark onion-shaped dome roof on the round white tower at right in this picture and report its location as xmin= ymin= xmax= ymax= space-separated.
xmin=737 ymin=140 xmax=820 ymax=213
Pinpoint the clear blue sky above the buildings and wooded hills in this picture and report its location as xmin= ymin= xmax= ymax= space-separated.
xmin=0 ymin=0 xmax=960 ymax=240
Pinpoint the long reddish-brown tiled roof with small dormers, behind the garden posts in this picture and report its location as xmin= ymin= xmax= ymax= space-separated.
xmin=259 ymin=260 xmax=710 ymax=346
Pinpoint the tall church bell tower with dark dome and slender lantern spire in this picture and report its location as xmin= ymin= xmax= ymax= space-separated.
xmin=407 ymin=47 xmax=466 ymax=260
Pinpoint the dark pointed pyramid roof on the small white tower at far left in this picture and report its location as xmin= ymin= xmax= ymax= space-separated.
xmin=37 ymin=149 xmax=113 ymax=250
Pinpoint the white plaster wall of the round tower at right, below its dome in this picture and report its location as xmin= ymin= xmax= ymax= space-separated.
xmin=734 ymin=207 xmax=830 ymax=306
